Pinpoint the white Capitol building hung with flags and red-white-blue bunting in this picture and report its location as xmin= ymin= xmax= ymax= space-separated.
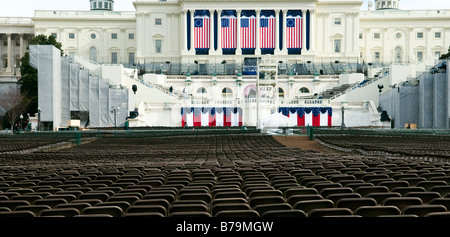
xmin=0 ymin=0 xmax=450 ymax=130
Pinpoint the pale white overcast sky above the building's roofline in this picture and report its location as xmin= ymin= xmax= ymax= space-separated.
xmin=0 ymin=0 xmax=450 ymax=17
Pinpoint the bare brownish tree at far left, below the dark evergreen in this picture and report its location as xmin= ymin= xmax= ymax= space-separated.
xmin=0 ymin=89 xmax=31 ymax=131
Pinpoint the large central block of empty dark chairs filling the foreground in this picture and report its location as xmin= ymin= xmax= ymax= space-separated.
xmin=0 ymin=135 xmax=450 ymax=217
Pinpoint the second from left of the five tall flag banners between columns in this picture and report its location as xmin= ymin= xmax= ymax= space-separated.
xmin=220 ymin=10 xmax=237 ymax=49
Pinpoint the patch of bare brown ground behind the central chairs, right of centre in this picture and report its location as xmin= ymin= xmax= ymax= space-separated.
xmin=273 ymin=136 xmax=338 ymax=153
